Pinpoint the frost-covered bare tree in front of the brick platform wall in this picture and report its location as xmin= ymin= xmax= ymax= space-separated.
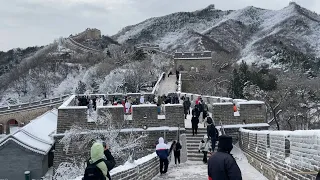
xmin=54 ymin=111 xmax=147 ymax=180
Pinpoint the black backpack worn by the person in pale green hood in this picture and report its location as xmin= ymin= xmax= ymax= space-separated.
xmin=83 ymin=159 xmax=106 ymax=180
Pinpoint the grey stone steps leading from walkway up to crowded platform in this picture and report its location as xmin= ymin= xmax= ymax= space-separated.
xmin=186 ymin=128 xmax=218 ymax=162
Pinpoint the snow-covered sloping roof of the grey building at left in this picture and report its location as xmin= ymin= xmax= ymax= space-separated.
xmin=0 ymin=109 xmax=58 ymax=154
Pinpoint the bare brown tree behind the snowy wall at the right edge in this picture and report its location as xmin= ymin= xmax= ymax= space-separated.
xmin=244 ymin=72 xmax=320 ymax=130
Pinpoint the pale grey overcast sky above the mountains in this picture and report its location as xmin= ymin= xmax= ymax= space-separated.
xmin=0 ymin=0 xmax=320 ymax=51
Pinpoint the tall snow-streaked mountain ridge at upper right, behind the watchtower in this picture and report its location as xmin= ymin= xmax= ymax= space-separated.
xmin=113 ymin=3 xmax=320 ymax=69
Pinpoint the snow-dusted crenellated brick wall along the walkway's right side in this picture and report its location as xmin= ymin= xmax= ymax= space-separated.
xmin=239 ymin=129 xmax=320 ymax=180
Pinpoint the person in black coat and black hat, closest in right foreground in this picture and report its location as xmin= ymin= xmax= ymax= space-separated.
xmin=208 ymin=135 xmax=242 ymax=180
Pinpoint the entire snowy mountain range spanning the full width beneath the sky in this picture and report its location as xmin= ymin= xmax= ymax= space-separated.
xmin=0 ymin=3 xmax=320 ymax=105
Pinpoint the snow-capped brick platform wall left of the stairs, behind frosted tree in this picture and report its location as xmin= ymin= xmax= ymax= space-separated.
xmin=54 ymin=96 xmax=185 ymax=171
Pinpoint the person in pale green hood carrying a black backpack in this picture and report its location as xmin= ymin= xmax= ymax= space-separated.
xmin=82 ymin=142 xmax=110 ymax=180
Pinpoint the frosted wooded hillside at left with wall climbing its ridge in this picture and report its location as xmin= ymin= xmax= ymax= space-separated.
xmin=0 ymin=29 xmax=170 ymax=106
